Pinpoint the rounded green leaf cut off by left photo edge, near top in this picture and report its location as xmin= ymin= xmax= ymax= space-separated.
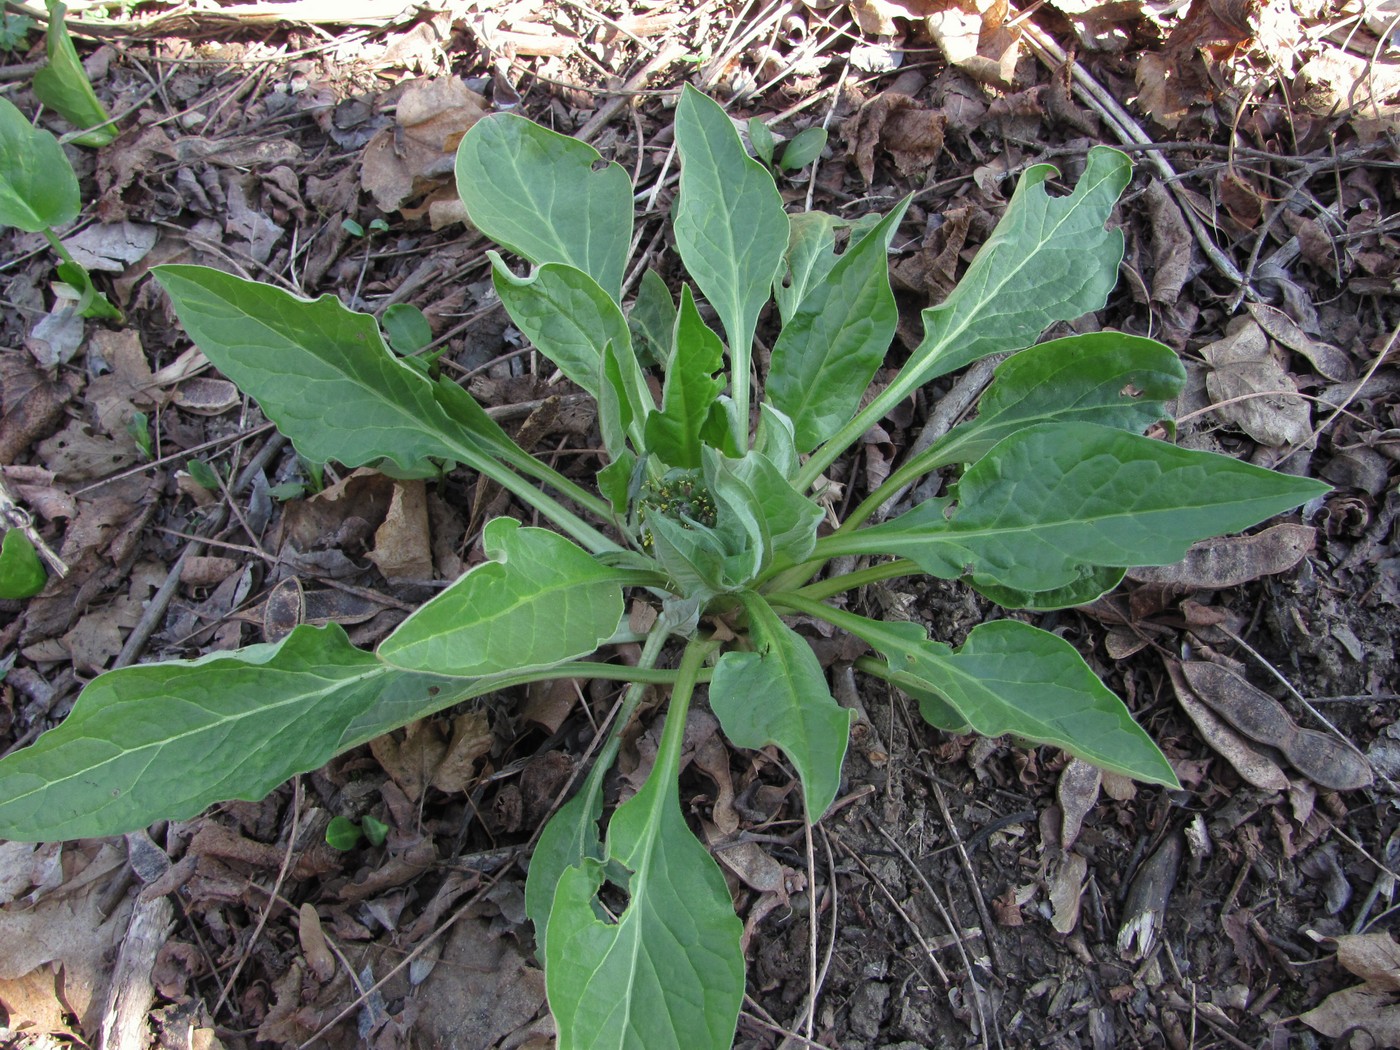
xmin=0 ymin=98 xmax=81 ymax=234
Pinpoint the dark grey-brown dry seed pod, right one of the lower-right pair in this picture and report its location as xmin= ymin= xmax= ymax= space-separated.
xmin=1182 ymin=661 xmax=1375 ymax=791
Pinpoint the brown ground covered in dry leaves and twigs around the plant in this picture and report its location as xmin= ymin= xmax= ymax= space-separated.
xmin=0 ymin=0 xmax=1400 ymax=1050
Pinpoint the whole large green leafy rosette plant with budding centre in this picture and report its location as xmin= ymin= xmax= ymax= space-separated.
xmin=0 ymin=88 xmax=1324 ymax=1050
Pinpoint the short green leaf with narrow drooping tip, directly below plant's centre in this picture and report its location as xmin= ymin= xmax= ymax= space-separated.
xmin=710 ymin=592 xmax=854 ymax=820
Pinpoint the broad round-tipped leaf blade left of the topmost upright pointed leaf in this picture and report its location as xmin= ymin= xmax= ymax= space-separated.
xmin=456 ymin=113 xmax=633 ymax=301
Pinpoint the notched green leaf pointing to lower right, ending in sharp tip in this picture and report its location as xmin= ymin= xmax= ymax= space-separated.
xmin=792 ymin=601 xmax=1179 ymax=788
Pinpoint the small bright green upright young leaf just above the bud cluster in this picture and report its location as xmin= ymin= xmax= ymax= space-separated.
xmin=645 ymin=284 xmax=724 ymax=469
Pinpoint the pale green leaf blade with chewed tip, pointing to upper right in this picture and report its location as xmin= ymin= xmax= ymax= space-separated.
xmin=909 ymin=146 xmax=1133 ymax=385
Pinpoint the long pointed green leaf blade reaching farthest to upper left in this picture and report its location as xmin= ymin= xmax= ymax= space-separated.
xmin=154 ymin=266 xmax=461 ymax=470
